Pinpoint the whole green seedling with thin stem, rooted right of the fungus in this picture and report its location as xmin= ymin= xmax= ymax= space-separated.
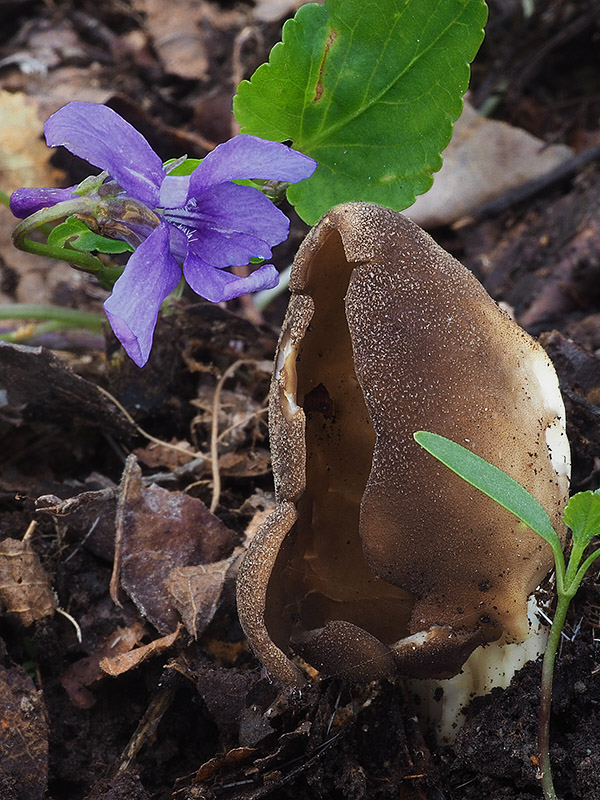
xmin=414 ymin=431 xmax=600 ymax=800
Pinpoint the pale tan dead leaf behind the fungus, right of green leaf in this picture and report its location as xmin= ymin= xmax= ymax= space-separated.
xmin=405 ymin=102 xmax=572 ymax=228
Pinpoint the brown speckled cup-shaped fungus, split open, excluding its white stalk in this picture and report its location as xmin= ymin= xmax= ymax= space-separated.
xmin=238 ymin=203 xmax=569 ymax=685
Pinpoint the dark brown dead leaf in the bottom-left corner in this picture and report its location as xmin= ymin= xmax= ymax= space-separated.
xmin=0 ymin=666 xmax=48 ymax=800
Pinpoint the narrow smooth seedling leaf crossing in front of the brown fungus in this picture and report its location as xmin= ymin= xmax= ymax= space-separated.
xmin=414 ymin=431 xmax=560 ymax=556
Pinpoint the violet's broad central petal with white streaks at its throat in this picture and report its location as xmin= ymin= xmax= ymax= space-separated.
xmin=165 ymin=183 xmax=290 ymax=267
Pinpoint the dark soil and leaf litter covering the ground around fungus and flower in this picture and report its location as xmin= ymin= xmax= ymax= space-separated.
xmin=0 ymin=0 xmax=600 ymax=800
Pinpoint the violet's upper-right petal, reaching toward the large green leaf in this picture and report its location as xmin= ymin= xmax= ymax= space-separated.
xmin=190 ymin=133 xmax=317 ymax=197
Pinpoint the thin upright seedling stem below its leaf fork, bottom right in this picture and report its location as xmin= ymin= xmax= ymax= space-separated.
xmin=538 ymin=594 xmax=572 ymax=800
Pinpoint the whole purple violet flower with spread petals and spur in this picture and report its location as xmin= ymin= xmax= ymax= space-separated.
xmin=10 ymin=102 xmax=317 ymax=367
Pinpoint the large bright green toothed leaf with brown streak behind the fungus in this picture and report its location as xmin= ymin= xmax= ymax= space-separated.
xmin=233 ymin=0 xmax=487 ymax=224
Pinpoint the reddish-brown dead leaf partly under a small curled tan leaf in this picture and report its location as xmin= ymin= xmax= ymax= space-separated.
xmin=60 ymin=622 xmax=148 ymax=708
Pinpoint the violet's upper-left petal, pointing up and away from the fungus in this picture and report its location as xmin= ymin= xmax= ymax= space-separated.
xmin=44 ymin=101 xmax=164 ymax=207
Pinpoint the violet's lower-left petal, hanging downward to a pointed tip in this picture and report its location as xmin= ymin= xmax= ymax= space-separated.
xmin=104 ymin=222 xmax=181 ymax=367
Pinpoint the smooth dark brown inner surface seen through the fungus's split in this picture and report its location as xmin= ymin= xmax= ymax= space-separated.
xmin=266 ymin=231 xmax=414 ymax=658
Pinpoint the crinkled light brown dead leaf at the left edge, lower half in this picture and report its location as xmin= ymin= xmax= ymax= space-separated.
xmin=0 ymin=539 xmax=56 ymax=627
